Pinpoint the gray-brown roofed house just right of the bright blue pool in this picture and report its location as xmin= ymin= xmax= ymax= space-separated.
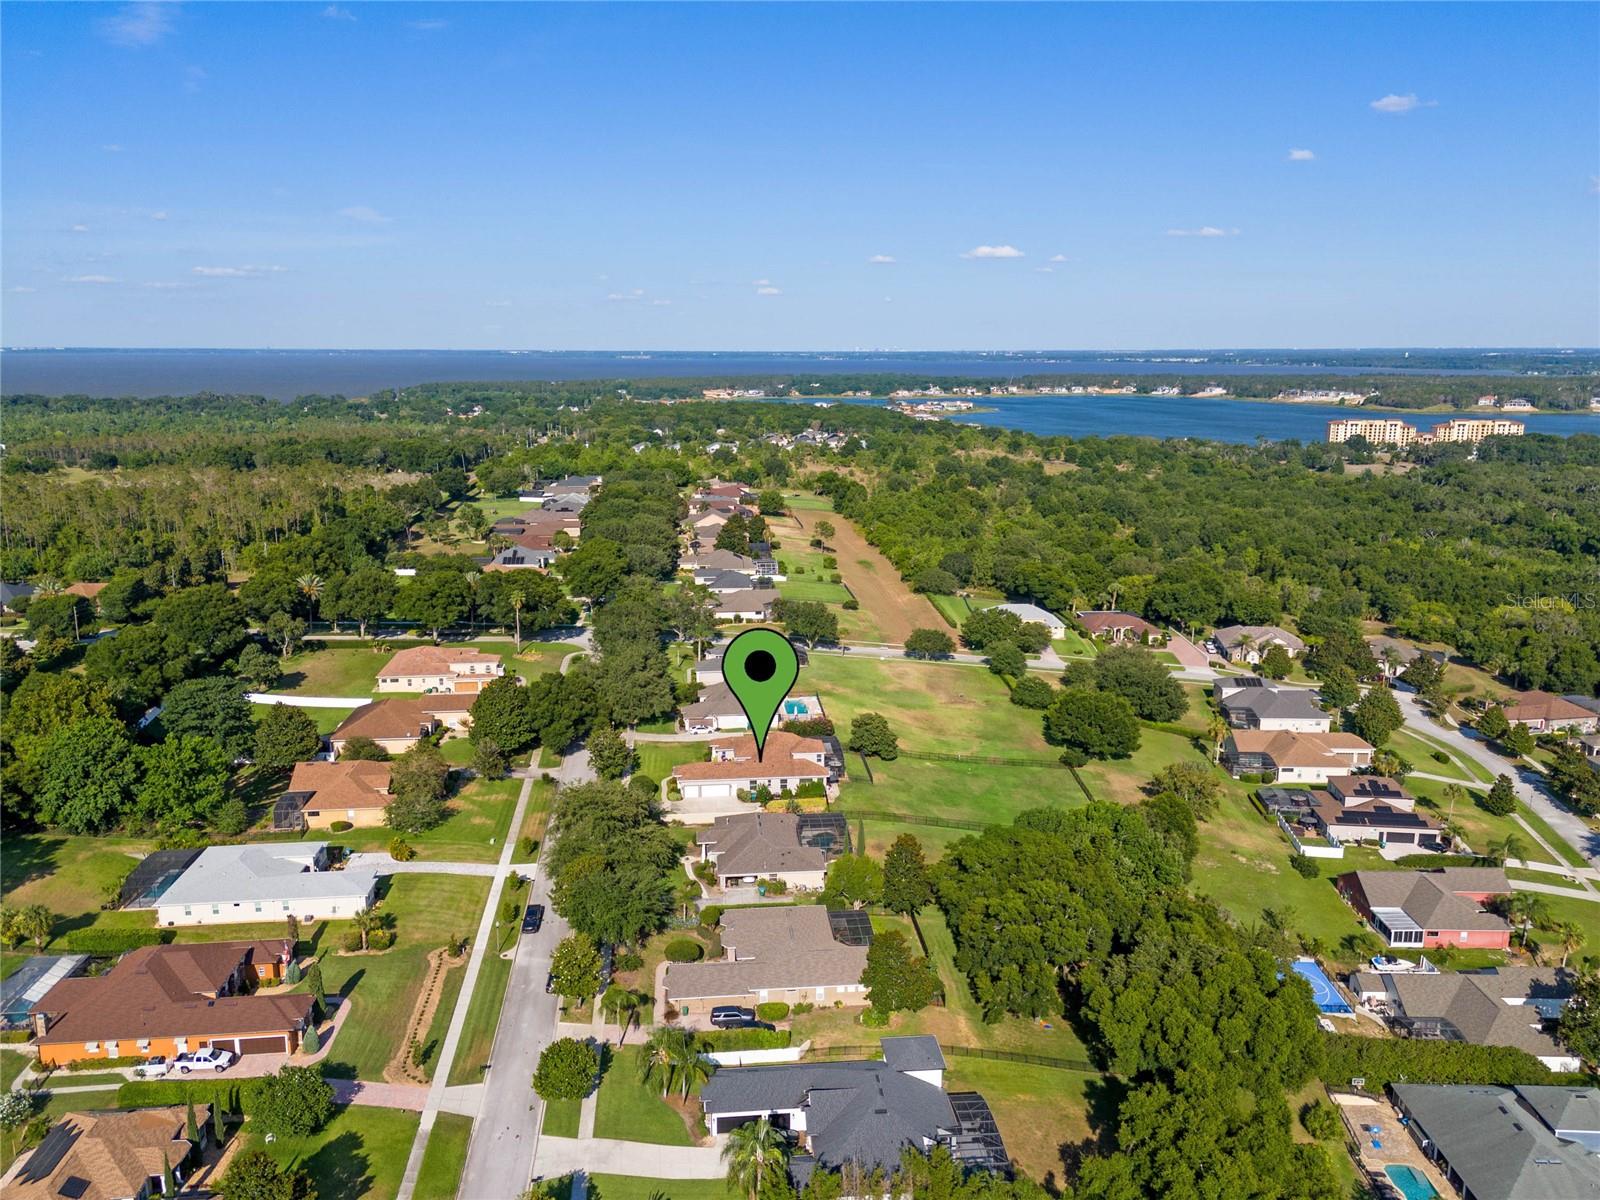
xmin=1352 ymin=966 xmax=1578 ymax=1070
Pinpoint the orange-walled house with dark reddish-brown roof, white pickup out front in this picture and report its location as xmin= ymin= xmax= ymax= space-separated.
xmin=32 ymin=941 xmax=314 ymax=1066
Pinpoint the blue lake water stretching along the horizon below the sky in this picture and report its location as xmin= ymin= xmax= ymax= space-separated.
xmin=0 ymin=349 xmax=1600 ymax=443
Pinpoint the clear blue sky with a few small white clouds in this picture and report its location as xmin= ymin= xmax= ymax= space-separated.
xmin=0 ymin=3 xmax=1600 ymax=349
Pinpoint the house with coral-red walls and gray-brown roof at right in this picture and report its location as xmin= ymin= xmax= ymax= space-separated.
xmin=1334 ymin=867 xmax=1510 ymax=950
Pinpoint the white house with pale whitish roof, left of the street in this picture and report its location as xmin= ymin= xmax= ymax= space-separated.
xmin=155 ymin=842 xmax=378 ymax=925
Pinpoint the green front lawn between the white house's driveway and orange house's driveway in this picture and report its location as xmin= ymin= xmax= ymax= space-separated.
xmin=312 ymin=874 xmax=490 ymax=1080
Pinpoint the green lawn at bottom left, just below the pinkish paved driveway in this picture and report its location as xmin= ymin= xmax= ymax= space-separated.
xmin=240 ymin=1107 xmax=419 ymax=1200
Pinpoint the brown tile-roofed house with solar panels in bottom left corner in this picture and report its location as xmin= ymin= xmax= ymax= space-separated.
xmin=0 ymin=1104 xmax=211 ymax=1200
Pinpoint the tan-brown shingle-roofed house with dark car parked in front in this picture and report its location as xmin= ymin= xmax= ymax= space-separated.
xmin=664 ymin=904 xmax=872 ymax=1018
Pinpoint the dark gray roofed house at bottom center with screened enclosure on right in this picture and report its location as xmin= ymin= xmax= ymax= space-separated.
xmin=701 ymin=1037 xmax=1010 ymax=1184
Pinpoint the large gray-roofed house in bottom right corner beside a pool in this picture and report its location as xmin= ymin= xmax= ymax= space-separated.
xmin=1390 ymin=1083 xmax=1600 ymax=1200
